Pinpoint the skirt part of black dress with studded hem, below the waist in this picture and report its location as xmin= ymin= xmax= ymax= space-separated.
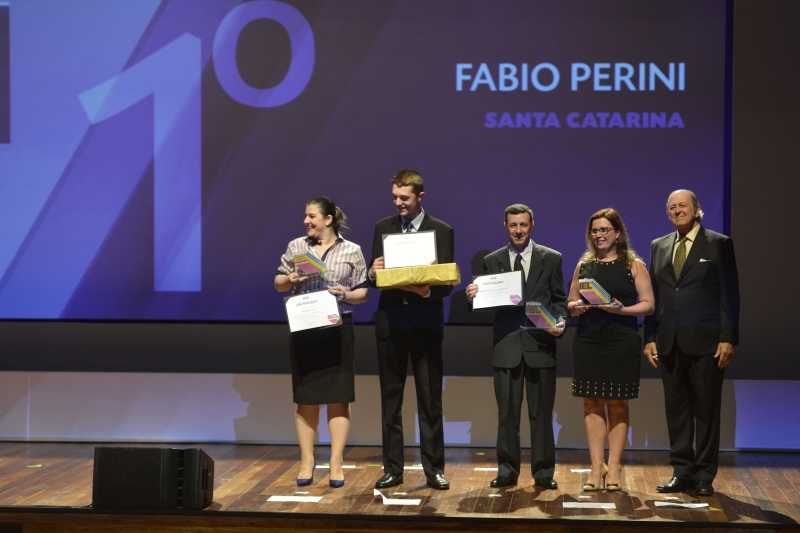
xmin=572 ymin=330 xmax=642 ymax=400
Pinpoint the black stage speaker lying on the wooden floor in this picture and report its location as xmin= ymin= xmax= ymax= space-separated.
xmin=92 ymin=446 xmax=214 ymax=510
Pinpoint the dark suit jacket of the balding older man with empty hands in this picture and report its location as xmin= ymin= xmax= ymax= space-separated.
xmin=644 ymin=222 xmax=739 ymax=355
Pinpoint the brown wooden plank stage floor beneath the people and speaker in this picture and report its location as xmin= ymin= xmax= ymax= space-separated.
xmin=0 ymin=442 xmax=800 ymax=533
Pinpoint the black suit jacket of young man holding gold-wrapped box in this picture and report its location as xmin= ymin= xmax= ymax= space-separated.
xmin=367 ymin=212 xmax=455 ymax=337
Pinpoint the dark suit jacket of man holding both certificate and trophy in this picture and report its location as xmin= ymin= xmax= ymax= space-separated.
xmin=483 ymin=243 xmax=568 ymax=368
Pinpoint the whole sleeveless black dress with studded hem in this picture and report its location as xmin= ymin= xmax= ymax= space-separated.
xmin=572 ymin=260 xmax=642 ymax=400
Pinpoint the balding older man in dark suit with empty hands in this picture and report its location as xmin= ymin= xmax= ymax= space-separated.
xmin=644 ymin=190 xmax=739 ymax=496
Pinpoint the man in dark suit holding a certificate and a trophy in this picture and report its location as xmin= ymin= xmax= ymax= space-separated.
xmin=466 ymin=204 xmax=567 ymax=489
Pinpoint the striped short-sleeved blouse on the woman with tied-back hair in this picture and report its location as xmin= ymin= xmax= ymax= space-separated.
xmin=278 ymin=237 xmax=369 ymax=314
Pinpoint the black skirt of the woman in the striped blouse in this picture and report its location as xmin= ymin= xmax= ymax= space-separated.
xmin=289 ymin=313 xmax=356 ymax=405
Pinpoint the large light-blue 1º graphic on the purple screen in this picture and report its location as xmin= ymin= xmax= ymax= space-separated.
xmin=79 ymin=0 xmax=314 ymax=291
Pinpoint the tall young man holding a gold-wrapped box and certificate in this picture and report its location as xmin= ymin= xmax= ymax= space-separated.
xmin=369 ymin=170 xmax=454 ymax=490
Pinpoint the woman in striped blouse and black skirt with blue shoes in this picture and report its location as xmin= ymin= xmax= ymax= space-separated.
xmin=275 ymin=196 xmax=369 ymax=487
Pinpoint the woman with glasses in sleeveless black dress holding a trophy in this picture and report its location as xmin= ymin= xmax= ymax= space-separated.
xmin=567 ymin=208 xmax=655 ymax=491
